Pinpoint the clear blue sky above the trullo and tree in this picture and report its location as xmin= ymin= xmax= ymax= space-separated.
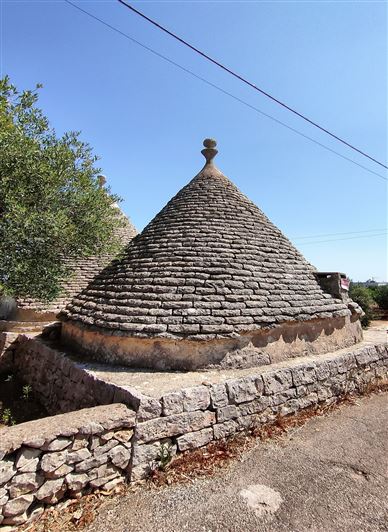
xmin=1 ymin=0 xmax=387 ymax=281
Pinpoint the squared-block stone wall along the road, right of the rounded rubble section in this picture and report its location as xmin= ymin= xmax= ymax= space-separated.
xmin=132 ymin=344 xmax=388 ymax=480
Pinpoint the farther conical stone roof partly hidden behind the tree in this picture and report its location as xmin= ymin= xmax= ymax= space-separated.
xmin=17 ymin=209 xmax=137 ymax=318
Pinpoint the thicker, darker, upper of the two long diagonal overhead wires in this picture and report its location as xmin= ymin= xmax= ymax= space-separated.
xmin=118 ymin=0 xmax=388 ymax=169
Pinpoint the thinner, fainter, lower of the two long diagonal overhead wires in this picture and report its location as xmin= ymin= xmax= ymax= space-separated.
xmin=64 ymin=0 xmax=388 ymax=181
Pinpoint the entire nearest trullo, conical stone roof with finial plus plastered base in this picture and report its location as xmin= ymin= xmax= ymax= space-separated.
xmin=62 ymin=139 xmax=361 ymax=369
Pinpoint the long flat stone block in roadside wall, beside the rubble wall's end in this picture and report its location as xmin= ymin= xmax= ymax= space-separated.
xmin=136 ymin=411 xmax=215 ymax=443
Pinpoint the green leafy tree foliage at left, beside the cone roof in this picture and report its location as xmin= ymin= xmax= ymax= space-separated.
xmin=0 ymin=77 xmax=123 ymax=300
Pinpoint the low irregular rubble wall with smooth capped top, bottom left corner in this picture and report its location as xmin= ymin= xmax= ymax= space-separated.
xmin=0 ymin=404 xmax=135 ymax=526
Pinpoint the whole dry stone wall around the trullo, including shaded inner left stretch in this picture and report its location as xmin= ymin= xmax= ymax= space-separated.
xmin=0 ymin=337 xmax=388 ymax=525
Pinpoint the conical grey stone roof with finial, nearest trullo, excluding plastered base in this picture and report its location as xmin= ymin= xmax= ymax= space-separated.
xmin=63 ymin=140 xmax=350 ymax=340
